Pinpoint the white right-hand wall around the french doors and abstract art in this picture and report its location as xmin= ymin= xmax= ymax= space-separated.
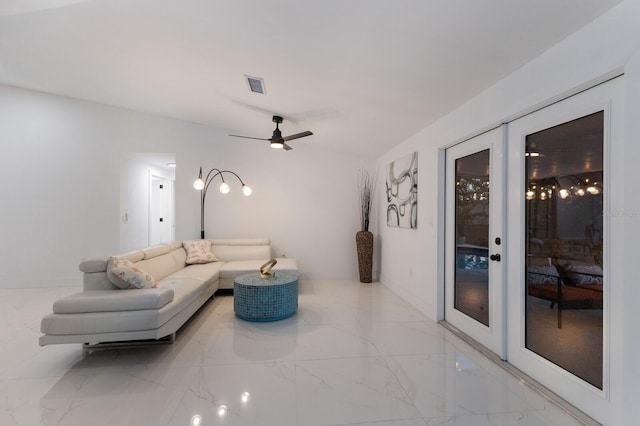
xmin=378 ymin=0 xmax=640 ymax=425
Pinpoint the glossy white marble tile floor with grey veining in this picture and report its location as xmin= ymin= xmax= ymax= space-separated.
xmin=0 ymin=281 xmax=592 ymax=426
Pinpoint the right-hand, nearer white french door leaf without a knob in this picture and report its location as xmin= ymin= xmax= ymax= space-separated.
xmin=506 ymin=78 xmax=624 ymax=421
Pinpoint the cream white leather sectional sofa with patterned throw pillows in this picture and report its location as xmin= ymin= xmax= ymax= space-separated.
xmin=40 ymin=239 xmax=298 ymax=347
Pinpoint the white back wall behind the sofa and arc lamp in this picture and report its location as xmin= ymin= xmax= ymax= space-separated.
xmin=0 ymin=86 xmax=373 ymax=288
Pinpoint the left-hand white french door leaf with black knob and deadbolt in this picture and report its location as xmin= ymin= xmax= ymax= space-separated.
xmin=445 ymin=127 xmax=507 ymax=358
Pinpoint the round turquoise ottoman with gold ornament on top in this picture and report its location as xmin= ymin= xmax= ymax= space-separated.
xmin=233 ymin=272 xmax=298 ymax=321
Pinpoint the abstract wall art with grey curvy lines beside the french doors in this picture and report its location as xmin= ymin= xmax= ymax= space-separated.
xmin=385 ymin=152 xmax=418 ymax=229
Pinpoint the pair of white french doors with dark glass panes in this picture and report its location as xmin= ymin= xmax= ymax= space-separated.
xmin=444 ymin=78 xmax=625 ymax=423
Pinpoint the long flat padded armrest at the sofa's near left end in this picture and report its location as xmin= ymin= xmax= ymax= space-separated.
xmin=53 ymin=288 xmax=174 ymax=314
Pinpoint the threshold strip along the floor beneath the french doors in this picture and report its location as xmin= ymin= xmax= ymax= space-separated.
xmin=438 ymin=321 xmax=602 ymax=426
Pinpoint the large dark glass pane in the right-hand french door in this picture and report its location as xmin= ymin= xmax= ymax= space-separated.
xmin=525 ymin=111 xmax=604 ymax=389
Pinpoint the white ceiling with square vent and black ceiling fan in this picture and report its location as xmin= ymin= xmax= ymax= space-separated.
xmin=0 ymin=0 xmax=619 ymax=157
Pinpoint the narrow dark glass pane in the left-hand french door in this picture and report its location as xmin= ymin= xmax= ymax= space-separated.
xmin=454 ymin=149 xmax=489 ymax=326
